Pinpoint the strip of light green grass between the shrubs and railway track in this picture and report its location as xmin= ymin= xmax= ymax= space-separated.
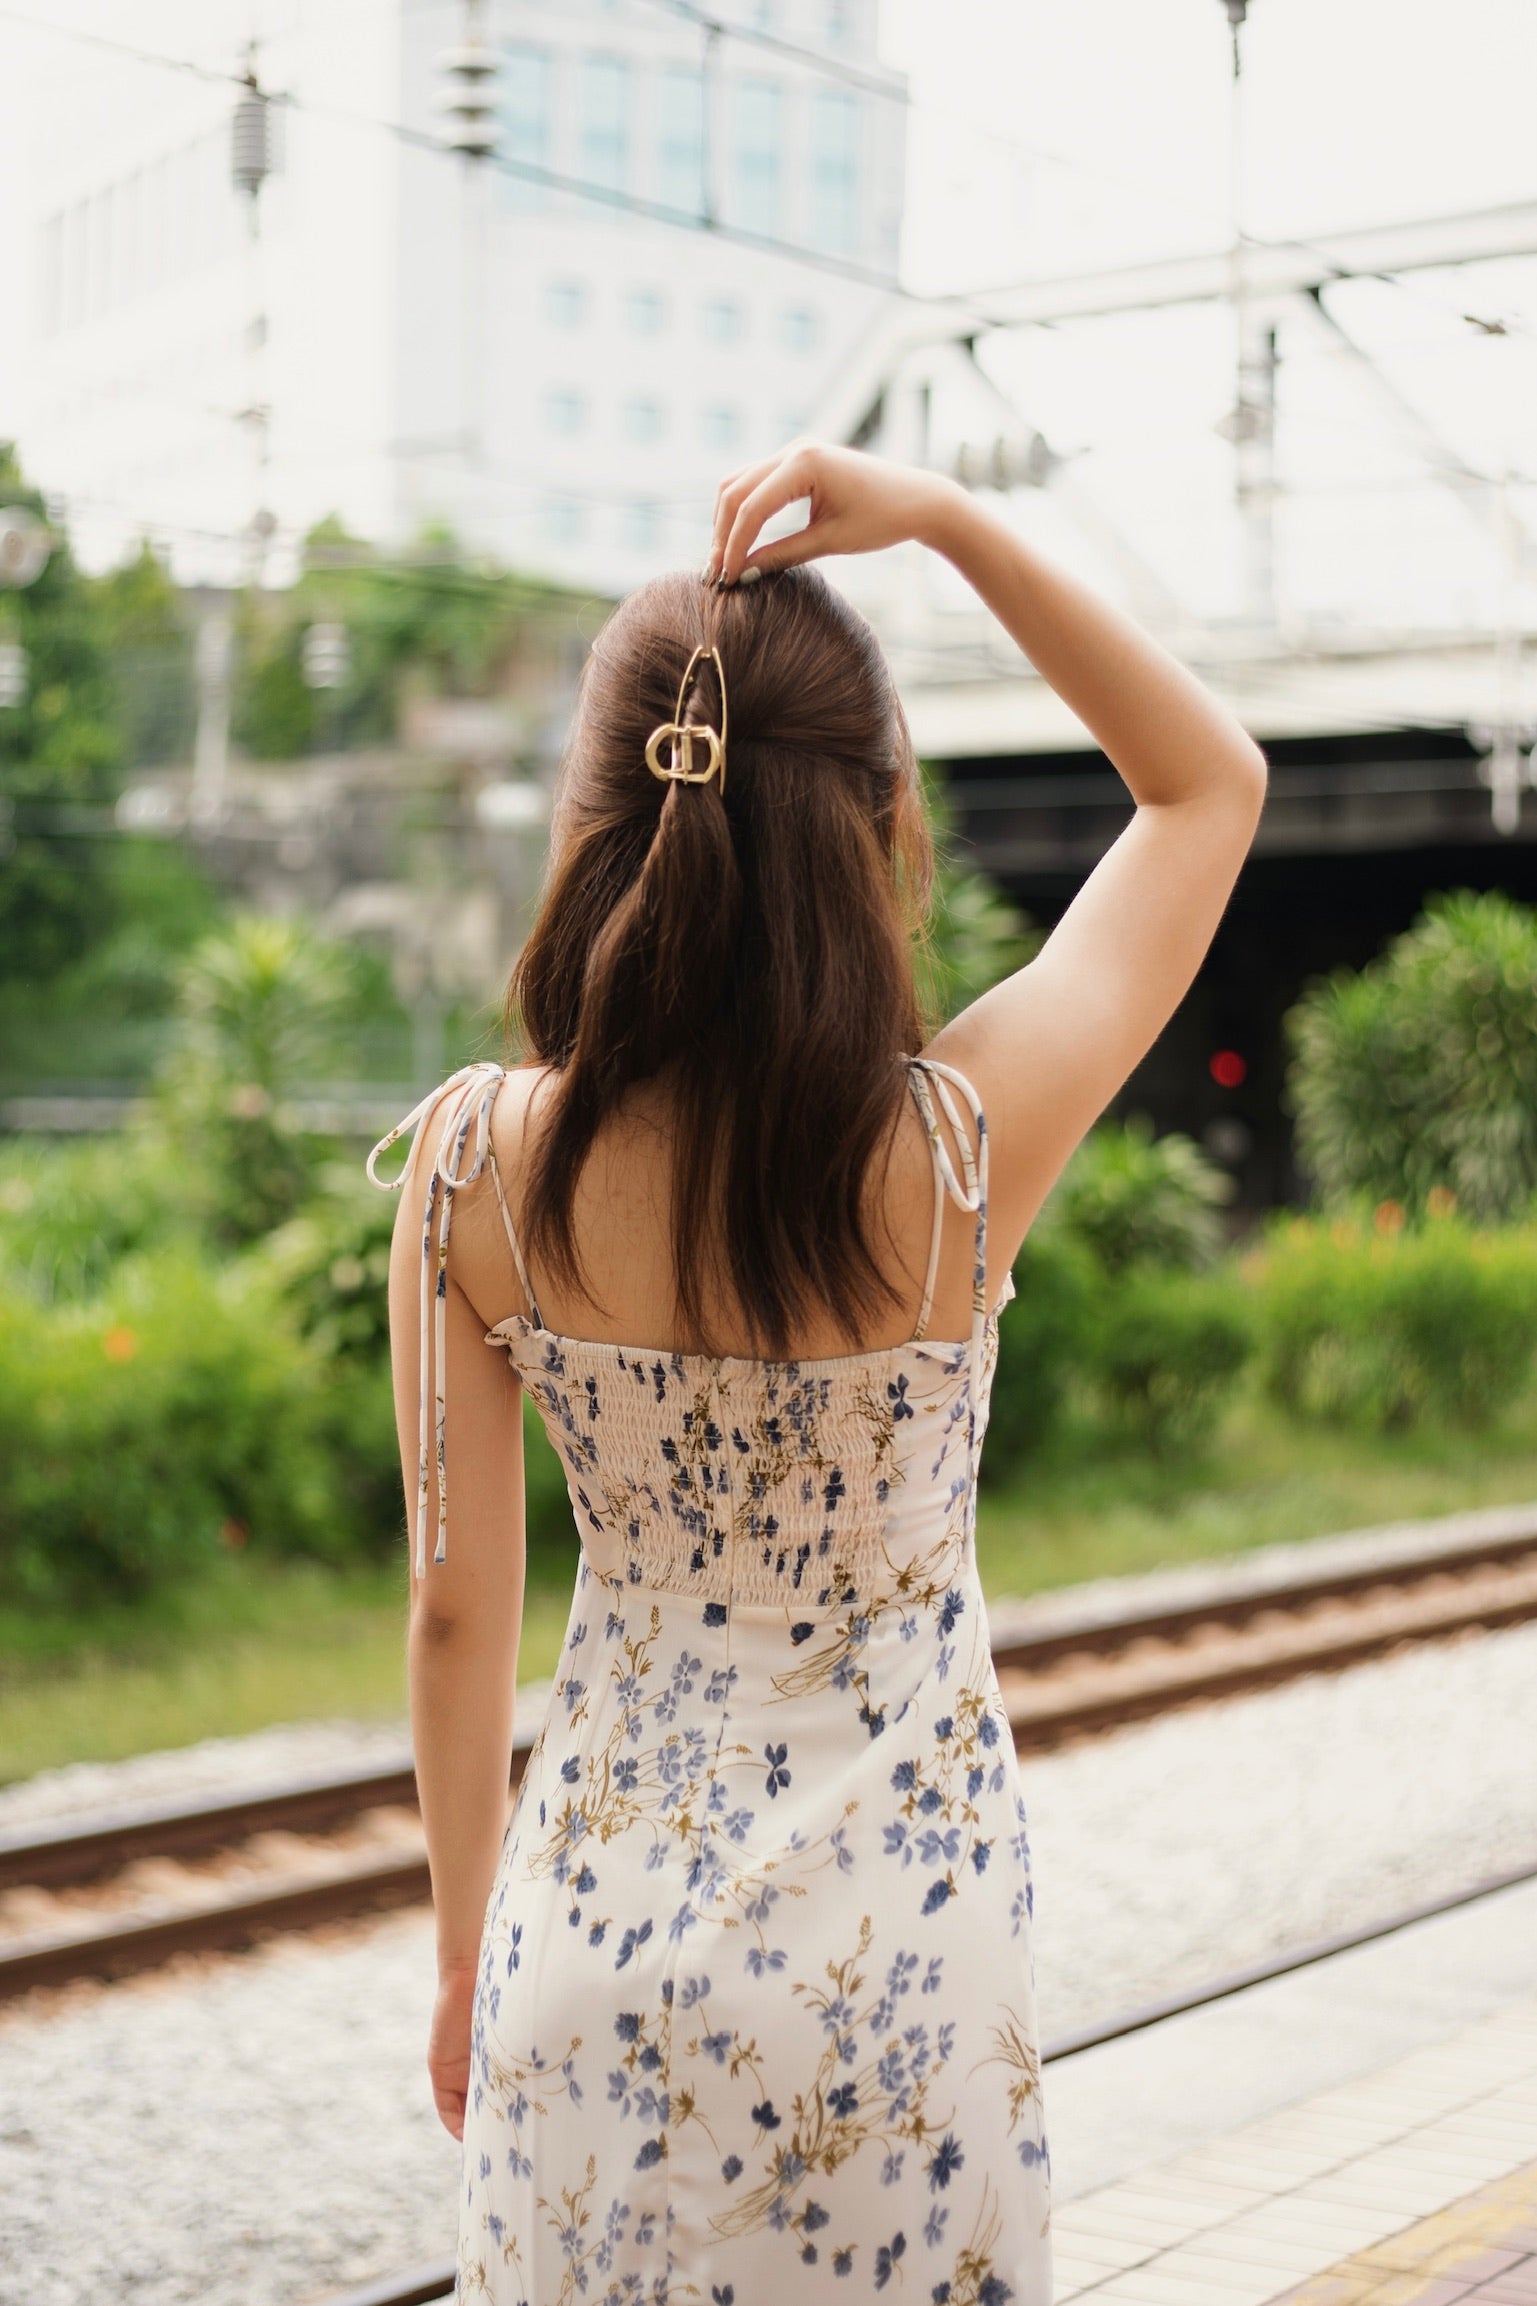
xmin=0 ymin=1393 xmax=1537 ymax=1783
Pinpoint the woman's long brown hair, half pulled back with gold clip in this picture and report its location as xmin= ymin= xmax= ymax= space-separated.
xmin=507 ymin=567 xmax=933 ymax=1356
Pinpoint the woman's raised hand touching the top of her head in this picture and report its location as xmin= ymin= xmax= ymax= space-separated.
xmin=705 ymin=440 xmax=961 ymax=583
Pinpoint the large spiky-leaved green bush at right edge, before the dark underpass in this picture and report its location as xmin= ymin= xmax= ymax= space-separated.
xmin=1288 ymin=892 xmax=1537 ymax=1224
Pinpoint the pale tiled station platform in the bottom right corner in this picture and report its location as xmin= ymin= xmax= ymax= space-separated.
xmin=1046 ymin=1884 xmax=1537 ymax=2306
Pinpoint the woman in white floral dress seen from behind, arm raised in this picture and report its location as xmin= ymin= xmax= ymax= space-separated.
xmin=368 ymin=443 xmax=1265 ymax=2306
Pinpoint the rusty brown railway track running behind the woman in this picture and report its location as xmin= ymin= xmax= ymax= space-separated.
xmin=0 ymin=1506 xmax=1537 ymax=2010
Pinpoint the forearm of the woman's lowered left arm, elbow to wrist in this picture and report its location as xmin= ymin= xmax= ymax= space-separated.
xmin=408 ymin=1614 xmax=516 ymax=1969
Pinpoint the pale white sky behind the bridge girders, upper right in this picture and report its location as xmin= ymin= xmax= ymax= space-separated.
xmin=0 ymin=0 xmax=1537 ymax=650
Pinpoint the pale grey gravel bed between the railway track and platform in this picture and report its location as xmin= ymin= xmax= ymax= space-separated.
xmin=0 ymin=1626 xmax=1537 ymax=2306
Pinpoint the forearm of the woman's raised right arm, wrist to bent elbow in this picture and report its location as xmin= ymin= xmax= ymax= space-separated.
xmin=922 ymin=487 xmax=1263 ymax=807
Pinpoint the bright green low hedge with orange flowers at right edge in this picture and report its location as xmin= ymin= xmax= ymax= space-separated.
xmin=1251 ymin=1213 xmax=1537 ymax=1427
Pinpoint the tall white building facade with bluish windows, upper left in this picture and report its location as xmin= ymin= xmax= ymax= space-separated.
xmin=18 ymin=0 xmax=906 ymax=590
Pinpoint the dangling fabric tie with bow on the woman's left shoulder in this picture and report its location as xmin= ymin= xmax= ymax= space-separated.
xmin=366 ymin=1061 xmax=507 ymax=1577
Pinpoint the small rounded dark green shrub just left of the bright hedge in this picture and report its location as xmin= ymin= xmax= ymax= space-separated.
xmin=1088 ymin=1261 xmax=1254 ymax=1453
